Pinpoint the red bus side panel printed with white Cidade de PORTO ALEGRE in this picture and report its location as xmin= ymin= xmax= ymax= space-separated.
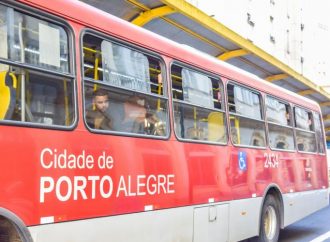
xmin=0 ymin=126 xmax=235 ymax=226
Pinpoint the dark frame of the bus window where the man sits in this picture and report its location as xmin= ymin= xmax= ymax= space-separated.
xmin=79 ymin=27 xmax=171 ymax=140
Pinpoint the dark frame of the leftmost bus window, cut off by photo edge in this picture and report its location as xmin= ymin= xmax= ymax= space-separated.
xmin=0 ymin=0 xmax=79 ymax=131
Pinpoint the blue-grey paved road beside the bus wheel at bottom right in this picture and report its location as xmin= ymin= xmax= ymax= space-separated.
xmin=244 ymin=195 xmax=330 ymax=242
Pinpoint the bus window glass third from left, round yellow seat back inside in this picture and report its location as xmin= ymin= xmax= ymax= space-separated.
xmin=171 ymin=65 xmax=227 ymax=143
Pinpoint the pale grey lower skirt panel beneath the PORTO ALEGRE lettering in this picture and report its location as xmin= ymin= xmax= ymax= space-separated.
xmin=29 ymin=207 xmax=193 ymax=242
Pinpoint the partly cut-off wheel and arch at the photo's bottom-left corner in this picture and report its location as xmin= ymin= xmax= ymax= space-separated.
xmin=0 ymin=208 xmax=32 ymax=242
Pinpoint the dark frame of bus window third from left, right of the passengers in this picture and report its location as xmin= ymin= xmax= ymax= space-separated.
xmin=169 ymin=59 xmax=229 ymax=146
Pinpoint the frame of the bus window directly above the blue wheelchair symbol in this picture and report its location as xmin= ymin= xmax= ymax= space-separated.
xmin=226 ymin=79 xmax=269 ymax=150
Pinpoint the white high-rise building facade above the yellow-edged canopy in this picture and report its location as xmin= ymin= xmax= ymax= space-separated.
xmin=187 ymin=0 xmax=330 ymax=91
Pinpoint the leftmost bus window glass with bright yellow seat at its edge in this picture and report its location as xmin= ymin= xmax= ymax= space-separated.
xmin=0 ymin=5 xmax=74 ymax=126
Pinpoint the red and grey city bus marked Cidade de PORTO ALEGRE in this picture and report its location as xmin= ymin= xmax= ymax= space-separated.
xmin=0 ymin=0 xmax=329 ymax=242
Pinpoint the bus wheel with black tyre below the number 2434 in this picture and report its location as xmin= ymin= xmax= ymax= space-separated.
xmin=258 ymin=187 xmax=283 ymax=242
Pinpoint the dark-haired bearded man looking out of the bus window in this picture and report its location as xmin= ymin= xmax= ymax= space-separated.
xmin=86 ymin=89 xmax=112 ymax=130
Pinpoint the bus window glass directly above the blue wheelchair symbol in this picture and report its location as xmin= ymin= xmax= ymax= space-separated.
xmin=227 ymin=84 xmax=266 ymax=147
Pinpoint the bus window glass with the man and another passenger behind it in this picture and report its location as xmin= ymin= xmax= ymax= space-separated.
xmin=83 ymin=34 xmax=168 ymax=137
